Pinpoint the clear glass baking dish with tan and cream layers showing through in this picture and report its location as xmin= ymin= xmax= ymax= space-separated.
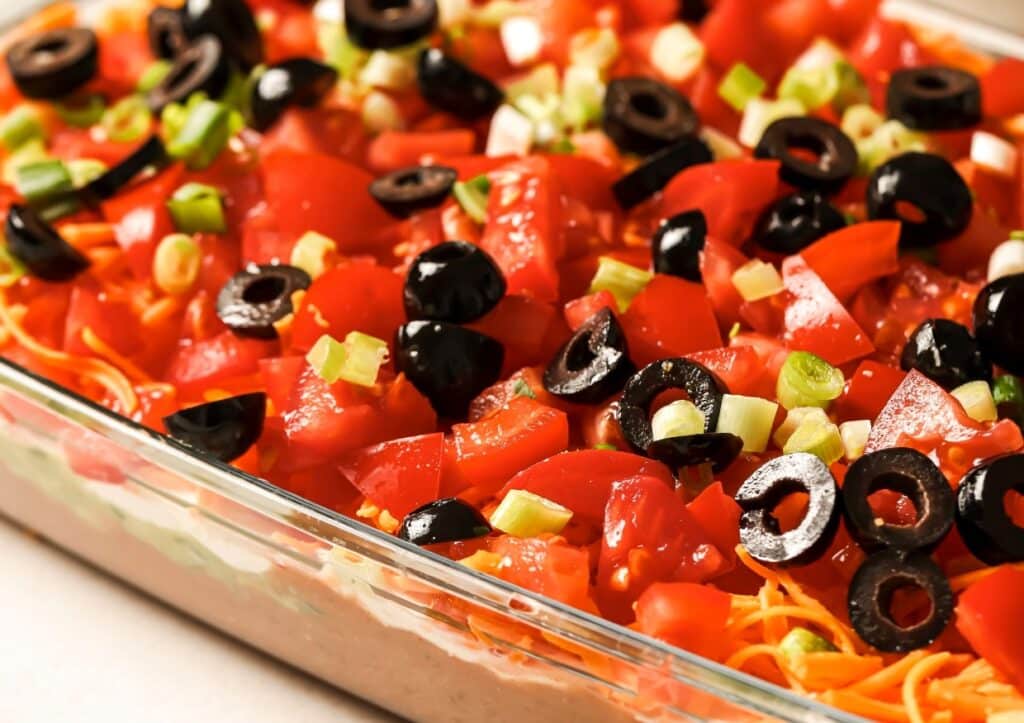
xmin=0 ymin=2 xmax=1015 ymax=723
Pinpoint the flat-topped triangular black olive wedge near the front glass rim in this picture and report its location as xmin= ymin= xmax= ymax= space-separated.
xmin=164 ymin=392 xmax=266 ymax=462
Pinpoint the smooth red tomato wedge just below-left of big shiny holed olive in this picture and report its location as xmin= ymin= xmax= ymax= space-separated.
xmin=800 ymin=221 xmax=899 ymax=303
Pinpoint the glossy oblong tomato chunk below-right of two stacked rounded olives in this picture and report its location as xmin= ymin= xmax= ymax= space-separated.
xmin=452 ymin=396 xmax=569 ymax=492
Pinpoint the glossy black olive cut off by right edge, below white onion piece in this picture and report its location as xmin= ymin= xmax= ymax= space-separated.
xmin=974 ymin=273 xmax=1024 ymax=376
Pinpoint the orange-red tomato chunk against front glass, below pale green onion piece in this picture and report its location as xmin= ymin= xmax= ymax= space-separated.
xmin=490 ymin=535 xmax=597 ymax=612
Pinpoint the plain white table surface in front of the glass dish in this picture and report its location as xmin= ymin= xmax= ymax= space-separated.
xmin=0 ymin=518 xmax=397 ymax=723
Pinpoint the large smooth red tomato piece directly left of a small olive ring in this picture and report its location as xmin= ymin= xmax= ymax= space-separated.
xmin=260 ymin=148 xmax=394 ymax=253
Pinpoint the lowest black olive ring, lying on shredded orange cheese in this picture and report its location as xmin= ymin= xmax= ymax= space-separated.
xmin=847 ymin=550 xmax=953 ymax=652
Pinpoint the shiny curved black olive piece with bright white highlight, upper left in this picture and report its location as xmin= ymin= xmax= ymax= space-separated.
xmin=249 ymin=57 xmax=338 ymax=131
